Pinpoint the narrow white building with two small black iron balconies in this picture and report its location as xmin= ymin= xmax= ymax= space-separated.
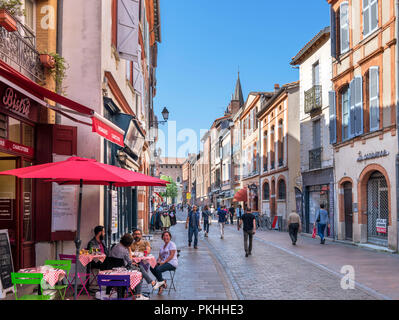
xmin=291 ymin=27 xmax=335 ymax=235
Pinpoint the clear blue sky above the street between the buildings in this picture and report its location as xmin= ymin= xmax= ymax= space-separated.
xmin=154 ymin=0 xmax=330 ymax=156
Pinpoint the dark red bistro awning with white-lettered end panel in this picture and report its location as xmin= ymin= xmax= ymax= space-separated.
xmin=0 ymin=60 xmax=125 ymax=147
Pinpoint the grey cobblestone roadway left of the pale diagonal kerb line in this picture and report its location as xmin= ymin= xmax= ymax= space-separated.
xmin=152 ymin=213 xmax=380 ymax=300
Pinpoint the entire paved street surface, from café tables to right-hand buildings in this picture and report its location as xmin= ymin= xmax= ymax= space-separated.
xmin=151 ymin=212 xmax=399 ymax=300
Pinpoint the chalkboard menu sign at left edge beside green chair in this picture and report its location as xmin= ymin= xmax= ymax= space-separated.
xmin=0 ymin=230 xmax=14 ymax=298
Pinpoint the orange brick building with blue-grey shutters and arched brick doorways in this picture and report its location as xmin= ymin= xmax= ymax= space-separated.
xmin=328 ymin=0 xmax=398 ymax=250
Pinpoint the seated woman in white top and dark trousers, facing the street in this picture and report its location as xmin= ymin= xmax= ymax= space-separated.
xmin=151 ymin=231 xmax=177 ymax=295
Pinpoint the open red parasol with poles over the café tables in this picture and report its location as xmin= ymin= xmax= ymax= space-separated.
xmin=0 ymin=157 xmax=169 ymax=299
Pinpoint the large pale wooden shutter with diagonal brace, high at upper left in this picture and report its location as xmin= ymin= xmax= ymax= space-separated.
xmin=117 ymin=0 xmax=139 ymax=62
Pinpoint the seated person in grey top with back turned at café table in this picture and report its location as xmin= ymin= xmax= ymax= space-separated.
xmin=107 ymin=233 xmax=149 ymax=300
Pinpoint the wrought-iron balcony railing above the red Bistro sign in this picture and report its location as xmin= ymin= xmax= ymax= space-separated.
xmin=0 ymin=19 xmax=44 ymax=82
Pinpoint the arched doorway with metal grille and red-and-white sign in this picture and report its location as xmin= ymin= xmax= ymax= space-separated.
xmin=367 ymin=171 xmax=389 ymax=246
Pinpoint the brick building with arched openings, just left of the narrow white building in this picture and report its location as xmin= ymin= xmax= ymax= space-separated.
xmin=260 ymin=82 xmax=301 ymax=230
